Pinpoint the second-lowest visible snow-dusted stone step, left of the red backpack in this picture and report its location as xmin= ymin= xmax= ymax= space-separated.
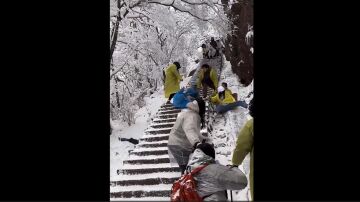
xmin=110 ymin=177 xmax=179 ymax=186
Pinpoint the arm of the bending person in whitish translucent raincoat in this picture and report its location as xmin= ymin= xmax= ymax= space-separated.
xmin=182 ymin=114 xmax=201 ymax=146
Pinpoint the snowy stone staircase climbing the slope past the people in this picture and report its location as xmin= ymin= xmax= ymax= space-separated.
xmin=110 ymin=55 xmax=221 ymax=201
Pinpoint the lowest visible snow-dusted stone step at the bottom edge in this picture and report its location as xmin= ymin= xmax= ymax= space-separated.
xmin=110 ymin=190 xmax=170 ymax=198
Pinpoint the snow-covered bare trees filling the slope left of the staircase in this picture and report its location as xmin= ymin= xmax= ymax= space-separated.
xmin=110 ymin=0 xmax=231 ymax=125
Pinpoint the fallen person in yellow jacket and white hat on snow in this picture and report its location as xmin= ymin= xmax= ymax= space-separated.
xmin=210 ymin=86 xmax=248 ymax=114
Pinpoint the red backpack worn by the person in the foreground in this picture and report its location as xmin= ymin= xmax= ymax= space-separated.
xmin=170 ymin=164 xmax=207 ymax=202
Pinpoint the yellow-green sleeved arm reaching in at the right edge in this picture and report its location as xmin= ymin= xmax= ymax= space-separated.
xmin=232 ymin=119 xmax=254 ymax=165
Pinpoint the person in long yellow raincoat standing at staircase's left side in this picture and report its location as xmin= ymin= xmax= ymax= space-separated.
xmin=164 ymin=62 xmax=182 ymax=101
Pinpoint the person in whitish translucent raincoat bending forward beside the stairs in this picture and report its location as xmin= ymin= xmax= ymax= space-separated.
xmin=168 ymin=98 xmax=205 ymax=174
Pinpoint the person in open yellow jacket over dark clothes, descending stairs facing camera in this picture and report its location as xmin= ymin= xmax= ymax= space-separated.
xmin=197 ymin=64 xmax=219 ymax=98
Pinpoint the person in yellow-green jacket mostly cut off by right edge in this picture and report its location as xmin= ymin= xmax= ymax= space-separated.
xmin=232 ymin=99 xmax=254 ymax=200
